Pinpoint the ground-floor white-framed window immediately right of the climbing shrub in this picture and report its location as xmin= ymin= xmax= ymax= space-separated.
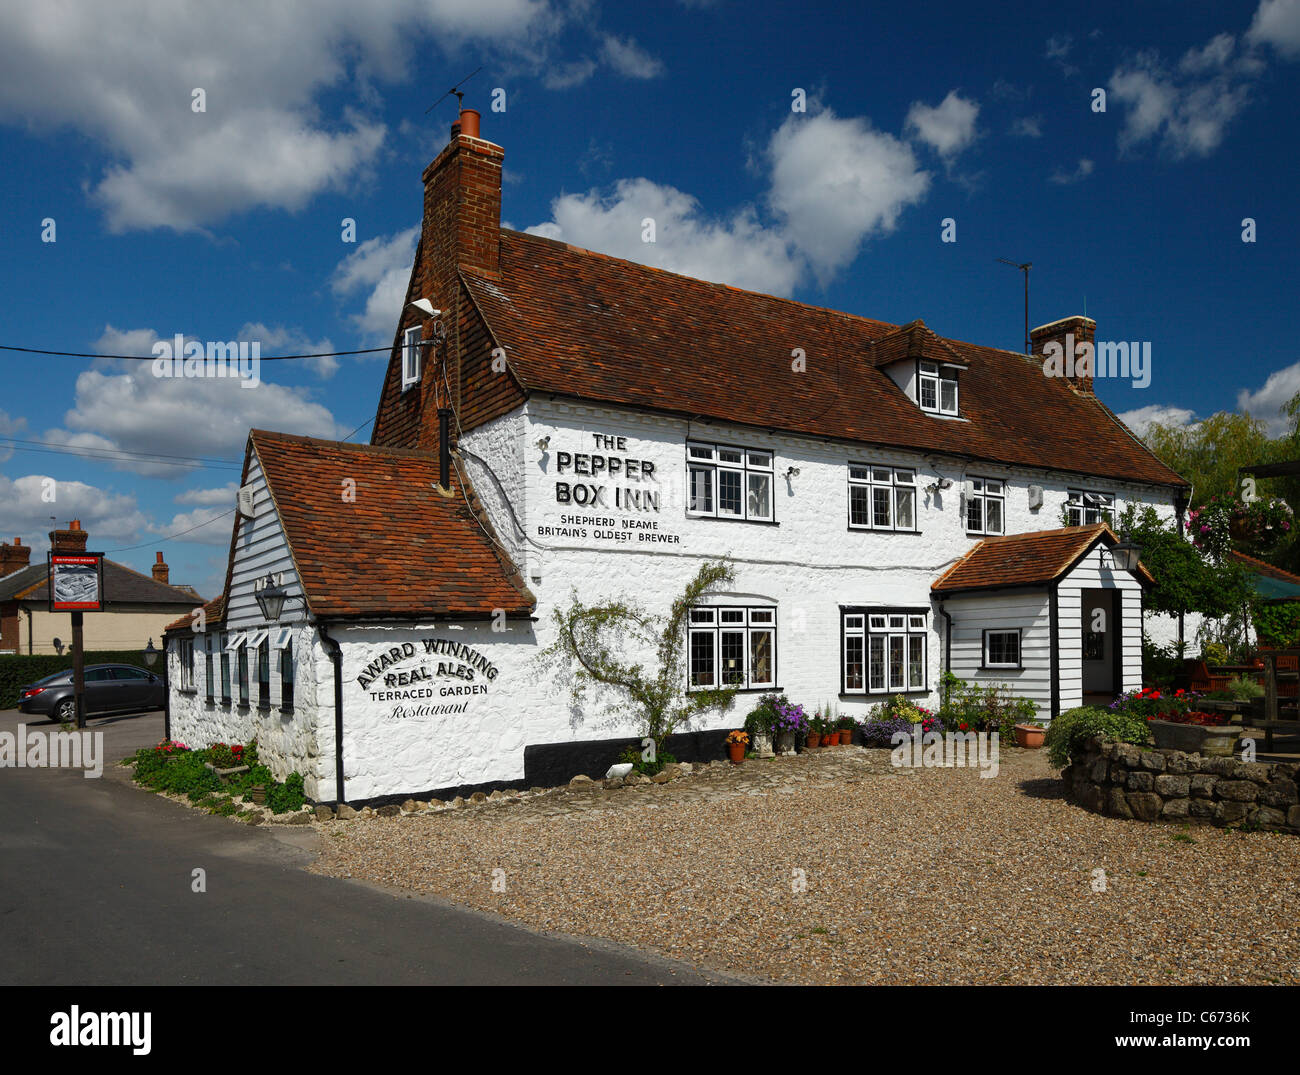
xmin=686 ymin=606 xmax=776 ymax=690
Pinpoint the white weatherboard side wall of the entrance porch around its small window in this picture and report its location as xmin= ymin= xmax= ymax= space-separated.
xmin=940 ymin=590 xmax=1052 ymax=720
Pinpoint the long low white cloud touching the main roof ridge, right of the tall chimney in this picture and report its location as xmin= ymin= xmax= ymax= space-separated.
xmin=525 ymin=178 xmax=801 ymax=295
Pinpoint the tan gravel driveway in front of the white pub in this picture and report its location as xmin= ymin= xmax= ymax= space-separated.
xmin=306 ymin=747 xmax=1300 ymax=984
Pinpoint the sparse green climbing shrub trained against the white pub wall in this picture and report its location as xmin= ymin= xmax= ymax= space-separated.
xmin=538 ymin=562 xmax=738 ymax=753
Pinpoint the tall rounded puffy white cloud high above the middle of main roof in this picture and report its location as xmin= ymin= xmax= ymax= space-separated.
xmin=767 ymin=109 xmax=930 ymax=281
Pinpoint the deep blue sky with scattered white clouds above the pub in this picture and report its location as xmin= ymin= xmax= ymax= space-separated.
xmin=0 ymin=0 xmax=1300 ymax=597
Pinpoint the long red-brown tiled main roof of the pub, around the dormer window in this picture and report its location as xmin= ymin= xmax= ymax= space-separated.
xmin=462 ymin=229 xmax=1186 ymax=486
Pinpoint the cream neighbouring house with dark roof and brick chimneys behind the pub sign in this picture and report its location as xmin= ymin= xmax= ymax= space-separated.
xmin=0 ymin=519 xmax=203 ymax=654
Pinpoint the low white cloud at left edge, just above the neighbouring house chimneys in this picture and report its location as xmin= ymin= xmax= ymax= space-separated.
xmin=0 ymin=474 xmax=148 ymax=553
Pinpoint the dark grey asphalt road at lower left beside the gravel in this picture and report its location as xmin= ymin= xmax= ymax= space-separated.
xmin=0 ymin=711 xmax=728 ymax=985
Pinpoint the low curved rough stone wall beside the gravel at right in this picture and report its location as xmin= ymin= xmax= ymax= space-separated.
xmin=1061 ymin=738 xmax=1300 ymax=833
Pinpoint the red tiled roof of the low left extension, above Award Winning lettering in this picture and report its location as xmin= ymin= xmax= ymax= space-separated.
xmin=250 ymin=429 xmax=536 ymax=617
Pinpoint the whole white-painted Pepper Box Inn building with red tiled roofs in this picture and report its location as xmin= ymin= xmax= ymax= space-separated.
xmin=168 ymin=110 xmax=1188 ymax=801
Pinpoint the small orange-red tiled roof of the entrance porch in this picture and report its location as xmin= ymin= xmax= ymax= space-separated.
xmin=931 ymin=523 xmax=1153 ymax=593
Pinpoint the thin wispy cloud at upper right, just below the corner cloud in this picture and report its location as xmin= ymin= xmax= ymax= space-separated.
xmin=1110 ymin=34 xmax=1261 ymax=160
